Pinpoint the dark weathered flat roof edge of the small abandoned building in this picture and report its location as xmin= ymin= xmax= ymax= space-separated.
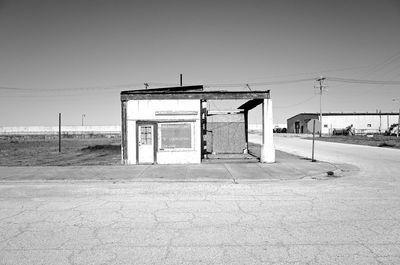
xmin=121 ymin=85 xmax=270 ymax=101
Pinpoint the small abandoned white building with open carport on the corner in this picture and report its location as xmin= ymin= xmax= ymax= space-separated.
xmin=121 ymin=85 xmax=275 ymax=164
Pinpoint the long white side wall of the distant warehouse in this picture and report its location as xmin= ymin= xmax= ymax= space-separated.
xmin=322 ymin=114 xmax=398 ymax=134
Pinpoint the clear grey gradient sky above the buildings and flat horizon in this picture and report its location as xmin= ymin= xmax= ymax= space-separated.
xmin=0 ymin=0 xmax=400 ymax=126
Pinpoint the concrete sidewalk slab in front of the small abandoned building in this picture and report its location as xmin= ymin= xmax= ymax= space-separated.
xmin=0 ymin=152 xmax=354 ymax=182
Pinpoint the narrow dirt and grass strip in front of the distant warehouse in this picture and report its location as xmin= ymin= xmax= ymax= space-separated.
xmin=309 ymin=135 xmax=400 ymax=148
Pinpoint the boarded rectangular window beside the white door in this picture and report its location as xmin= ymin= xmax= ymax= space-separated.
xmin=159 ymin=122 xmax=192 ymax=150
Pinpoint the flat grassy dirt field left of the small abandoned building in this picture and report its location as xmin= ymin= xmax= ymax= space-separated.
xmin=0 ymin=137 xmax=121 ymax=166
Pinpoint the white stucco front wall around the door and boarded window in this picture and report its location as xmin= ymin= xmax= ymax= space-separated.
xmin=127 ymin=99 xmax=201 ymax=164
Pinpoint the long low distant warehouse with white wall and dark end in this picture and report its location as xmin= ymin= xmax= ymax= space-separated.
xmin=287 ymin=112 xmax=398 ymax=134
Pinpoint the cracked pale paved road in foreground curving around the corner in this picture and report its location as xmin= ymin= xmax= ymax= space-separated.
xmin=0 ymin=135 xmax=400 ymax=265
